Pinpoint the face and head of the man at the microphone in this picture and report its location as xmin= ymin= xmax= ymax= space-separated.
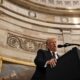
xmin=47 ymin=38 xmax=57 ymax=52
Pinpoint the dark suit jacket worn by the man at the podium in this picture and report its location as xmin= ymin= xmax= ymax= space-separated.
xmin=31 ymin=49 xmax=59 ymax=80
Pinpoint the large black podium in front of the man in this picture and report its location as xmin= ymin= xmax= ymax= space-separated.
xmin=45 ymin=47 xmax=80 ymax=80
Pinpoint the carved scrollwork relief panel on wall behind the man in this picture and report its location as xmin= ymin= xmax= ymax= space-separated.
xmin=7 ymin=33 xmax=45 ymax=52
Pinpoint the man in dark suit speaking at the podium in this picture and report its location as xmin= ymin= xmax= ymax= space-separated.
xmin=31 ymin=38 xmax=58 ymax=80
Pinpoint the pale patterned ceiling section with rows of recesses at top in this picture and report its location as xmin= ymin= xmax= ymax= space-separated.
xmin=29 ymin=0 xmax=80 ymax=9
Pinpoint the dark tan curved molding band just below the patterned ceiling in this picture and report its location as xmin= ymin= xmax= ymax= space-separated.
xmin=8 ymin=0 xmax=80 ymax=16
